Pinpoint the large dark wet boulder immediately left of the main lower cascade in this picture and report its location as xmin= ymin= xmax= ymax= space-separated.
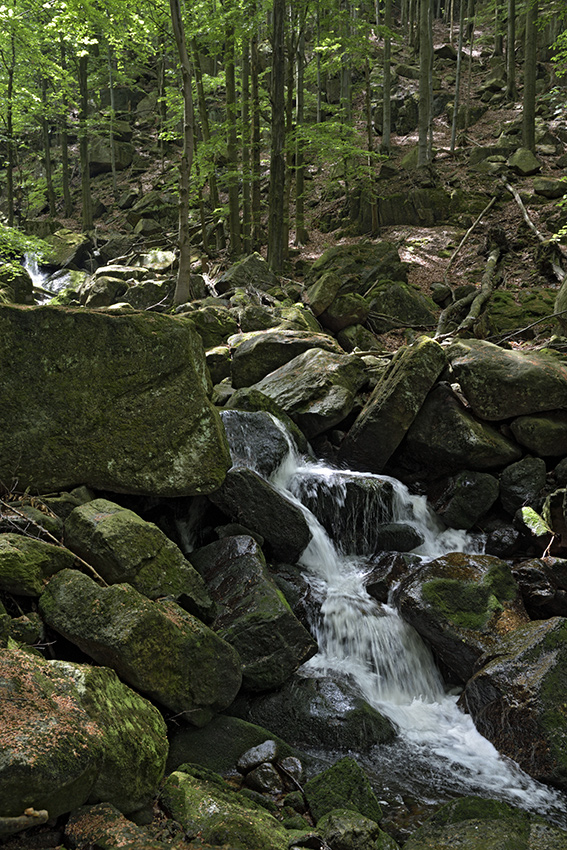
xmin=193 ymin=536 xmax=317 ymax=691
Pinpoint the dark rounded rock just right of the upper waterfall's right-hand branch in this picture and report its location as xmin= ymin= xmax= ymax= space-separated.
xmin=432 ymin=470 xmax=499 ymax=531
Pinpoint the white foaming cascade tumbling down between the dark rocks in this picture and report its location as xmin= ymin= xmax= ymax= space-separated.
xmin=271 ymin=438 xmax=565 ymax=817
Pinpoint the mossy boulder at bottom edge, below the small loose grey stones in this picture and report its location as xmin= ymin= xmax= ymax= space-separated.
xmin=160 ymin=766 xmax=288 ymax=850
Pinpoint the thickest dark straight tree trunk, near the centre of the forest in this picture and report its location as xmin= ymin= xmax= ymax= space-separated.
xmin=268 ymin=0 xmax=287 ymax=274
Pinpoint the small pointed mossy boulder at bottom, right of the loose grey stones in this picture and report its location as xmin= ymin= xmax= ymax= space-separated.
xmin=304 ymin=756 xmax=382 ymax=823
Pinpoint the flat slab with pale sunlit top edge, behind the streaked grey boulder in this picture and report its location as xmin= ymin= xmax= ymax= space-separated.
xmin=228 ymin=328 xmax=344 ymax=389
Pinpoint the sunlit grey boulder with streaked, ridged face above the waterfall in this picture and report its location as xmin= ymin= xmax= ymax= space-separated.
xmin=254 ymin=348 xmax=365 ymax=439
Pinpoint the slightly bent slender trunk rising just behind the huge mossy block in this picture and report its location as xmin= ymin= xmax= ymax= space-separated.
xmin=169 ymin=0 xmax=194 ymax=305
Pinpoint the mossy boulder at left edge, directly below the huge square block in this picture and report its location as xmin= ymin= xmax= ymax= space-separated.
xmin=0 ymin=533 xmax=75 ymax=596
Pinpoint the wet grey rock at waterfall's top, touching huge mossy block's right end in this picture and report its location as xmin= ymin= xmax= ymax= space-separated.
xmin=221 ymin=410 xmax=294 ymax=478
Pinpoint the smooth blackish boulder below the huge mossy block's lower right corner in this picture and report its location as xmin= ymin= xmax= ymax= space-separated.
xmin=209 ymin=466 xmax=311 ymax=564
